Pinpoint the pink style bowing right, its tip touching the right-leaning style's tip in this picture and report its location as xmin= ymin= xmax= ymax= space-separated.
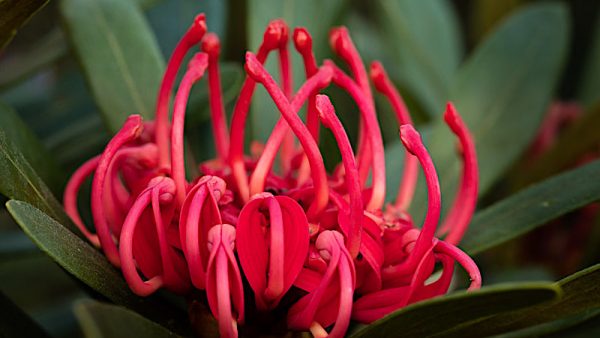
xmin=325 ymin=61 xmax=385 ymax=210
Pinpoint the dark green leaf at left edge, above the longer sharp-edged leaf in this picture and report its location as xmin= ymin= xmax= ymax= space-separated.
xmin=0 ymin=102 xmax=64 ymax=193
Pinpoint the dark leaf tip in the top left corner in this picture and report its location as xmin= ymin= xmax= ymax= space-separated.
xmin=0 ymin=0 xmax=48 ymax=51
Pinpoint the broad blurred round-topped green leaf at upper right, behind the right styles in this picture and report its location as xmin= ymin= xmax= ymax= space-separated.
xmin=388 ymin=3 xmax=569 ymax=220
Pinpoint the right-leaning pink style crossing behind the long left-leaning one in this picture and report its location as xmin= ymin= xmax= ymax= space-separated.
xmin=250 ymin=66 xmax=332 ymax=195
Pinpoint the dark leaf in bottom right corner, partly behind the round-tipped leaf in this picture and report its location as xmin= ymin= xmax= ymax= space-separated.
xmin=438 ymin=264 xmax=600 ymax=337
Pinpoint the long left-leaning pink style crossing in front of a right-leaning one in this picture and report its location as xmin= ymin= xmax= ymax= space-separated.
xmin=245 ymin=52 xmax=329 ymax=219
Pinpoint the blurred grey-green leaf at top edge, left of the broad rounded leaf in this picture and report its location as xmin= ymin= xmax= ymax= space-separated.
xmin=374 ymin=0 xmax=462 ymax=116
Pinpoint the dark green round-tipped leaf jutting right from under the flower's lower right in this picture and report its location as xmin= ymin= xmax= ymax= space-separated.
xmin=351 ymin=283 xmax=561 ymax=338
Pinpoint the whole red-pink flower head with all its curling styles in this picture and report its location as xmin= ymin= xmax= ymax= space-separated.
xmin=64 ymin=14 xmax=481 ymax=337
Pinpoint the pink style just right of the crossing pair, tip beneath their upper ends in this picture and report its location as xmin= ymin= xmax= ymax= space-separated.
xmin=316 ymin=95 xmax=363 ymax=259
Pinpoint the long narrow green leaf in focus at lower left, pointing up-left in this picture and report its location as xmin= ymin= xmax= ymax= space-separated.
xmin=6 ymin=200 xmax=191 ymax=332
